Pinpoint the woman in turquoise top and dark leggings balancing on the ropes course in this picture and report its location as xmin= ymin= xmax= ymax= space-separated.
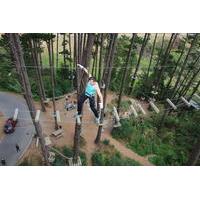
xmin=77 ymin=64 xmax=103 ymax=123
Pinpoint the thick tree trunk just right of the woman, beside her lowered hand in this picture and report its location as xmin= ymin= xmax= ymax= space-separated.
xmin=95 ymin=34 xmax=118 ymax=144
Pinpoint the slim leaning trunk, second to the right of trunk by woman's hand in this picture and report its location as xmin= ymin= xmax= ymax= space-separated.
xmin=129 ymin=33 xmax=148 ymax=95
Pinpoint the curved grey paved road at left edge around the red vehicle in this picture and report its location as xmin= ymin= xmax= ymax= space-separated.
xmin=0 ymin=92 xmax=35 ymax=166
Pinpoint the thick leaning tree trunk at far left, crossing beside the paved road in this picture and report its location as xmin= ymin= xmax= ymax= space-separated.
xmin=7 ymin=33 xmax=50 ymax=165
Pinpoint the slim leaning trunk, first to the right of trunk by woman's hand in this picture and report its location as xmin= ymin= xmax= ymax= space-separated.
xmin=117 ymin=33 xmax=136 ymax=113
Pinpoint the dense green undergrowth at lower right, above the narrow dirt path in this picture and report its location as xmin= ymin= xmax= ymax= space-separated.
xmin=112 ymin=112 xmax=200 ymax=165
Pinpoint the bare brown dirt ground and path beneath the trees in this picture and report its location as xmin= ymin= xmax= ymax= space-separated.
xmin=18 ymin=92 xmax=152 ymax=165
